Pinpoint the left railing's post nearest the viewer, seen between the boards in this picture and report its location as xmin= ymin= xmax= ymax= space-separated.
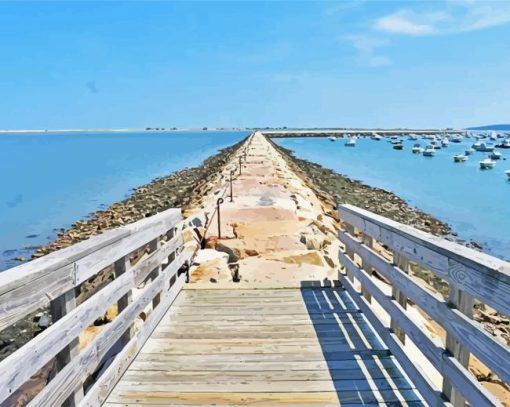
xmin=50 ymin=288 xmax=84 ymax=407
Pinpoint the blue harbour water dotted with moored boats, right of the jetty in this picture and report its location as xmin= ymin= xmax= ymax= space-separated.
xmin=274 ymin=137 xmax=510 ymax=260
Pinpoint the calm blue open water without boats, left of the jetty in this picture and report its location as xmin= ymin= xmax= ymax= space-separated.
xmin=0 ymin=131 xmax=249 ymax=270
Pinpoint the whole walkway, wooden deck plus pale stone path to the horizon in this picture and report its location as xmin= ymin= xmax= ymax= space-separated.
xmin=106 ymin=133 xmax=423 ymax=406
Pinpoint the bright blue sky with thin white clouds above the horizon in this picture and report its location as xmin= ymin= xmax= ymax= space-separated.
xmin=0 ymin=0 xmax=510 ymax=129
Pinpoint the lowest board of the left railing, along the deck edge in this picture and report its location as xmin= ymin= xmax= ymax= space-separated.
xmin=80 ymin=274 xmax=186 ymax=407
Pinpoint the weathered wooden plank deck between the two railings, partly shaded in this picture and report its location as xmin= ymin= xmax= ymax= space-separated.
xmin=102 ymin=288 xmax=422 ymax=407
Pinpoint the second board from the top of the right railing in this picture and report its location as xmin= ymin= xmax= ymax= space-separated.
xmin=340 ymin=233 xmax=510 ymax=383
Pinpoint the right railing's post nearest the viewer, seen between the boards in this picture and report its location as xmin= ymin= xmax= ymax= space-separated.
xmin=443 ymin=285 xmax=473 ymax=407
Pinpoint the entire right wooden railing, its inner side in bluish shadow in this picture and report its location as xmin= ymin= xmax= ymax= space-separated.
xmin=339 ymin=205 xmax=510 ymax=407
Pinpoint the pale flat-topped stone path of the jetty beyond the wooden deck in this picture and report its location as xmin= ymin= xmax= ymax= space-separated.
xmin=181 ymin=133 xmax=338 ymax=288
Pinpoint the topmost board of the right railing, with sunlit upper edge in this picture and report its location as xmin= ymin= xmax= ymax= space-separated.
xmin=339 ymin=205 xmax=510 ymax=315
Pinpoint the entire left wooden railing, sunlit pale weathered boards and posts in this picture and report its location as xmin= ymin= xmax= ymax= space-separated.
xmin=0 ymin=209 xmax=191 ymax=406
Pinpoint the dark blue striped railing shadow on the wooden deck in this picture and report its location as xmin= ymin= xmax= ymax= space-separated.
xmin=301 ymin=281 xmax=424 ymax=406
